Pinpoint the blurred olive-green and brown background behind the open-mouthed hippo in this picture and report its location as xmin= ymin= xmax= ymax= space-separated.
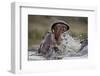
xmin=28 ymin=15 xmax=88 ymax=48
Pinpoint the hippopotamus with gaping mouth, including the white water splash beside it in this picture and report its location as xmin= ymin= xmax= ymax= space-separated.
xmin=38 ymin=20 xmax=87 ymax=59
